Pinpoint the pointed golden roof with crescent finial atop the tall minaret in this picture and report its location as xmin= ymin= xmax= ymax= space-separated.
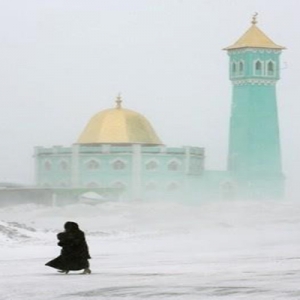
xmin=224 ymin=13 xmax=285 ymax=50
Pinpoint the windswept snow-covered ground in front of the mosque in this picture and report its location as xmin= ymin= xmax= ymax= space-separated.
xmin=0 ymin=202 xmax=300 ymax=300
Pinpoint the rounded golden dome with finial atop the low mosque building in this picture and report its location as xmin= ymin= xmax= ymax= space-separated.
xmin=77 ymin=96 xmax=162 ymax=145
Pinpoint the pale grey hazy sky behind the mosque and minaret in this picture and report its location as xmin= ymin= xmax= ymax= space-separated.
xmin=0 ymin=0 xmax=300 ymax=195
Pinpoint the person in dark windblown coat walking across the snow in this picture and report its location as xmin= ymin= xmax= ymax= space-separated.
xmin=46 ymin=222 xmax=91 ymax=274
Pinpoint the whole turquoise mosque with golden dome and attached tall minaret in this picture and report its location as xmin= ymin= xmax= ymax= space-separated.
xmin=34 ymin=16 xmax=285 ymax=201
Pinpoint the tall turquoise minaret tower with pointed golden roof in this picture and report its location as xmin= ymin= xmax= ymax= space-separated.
xmin=225 ymin=14 xmax=284 ymax=199
